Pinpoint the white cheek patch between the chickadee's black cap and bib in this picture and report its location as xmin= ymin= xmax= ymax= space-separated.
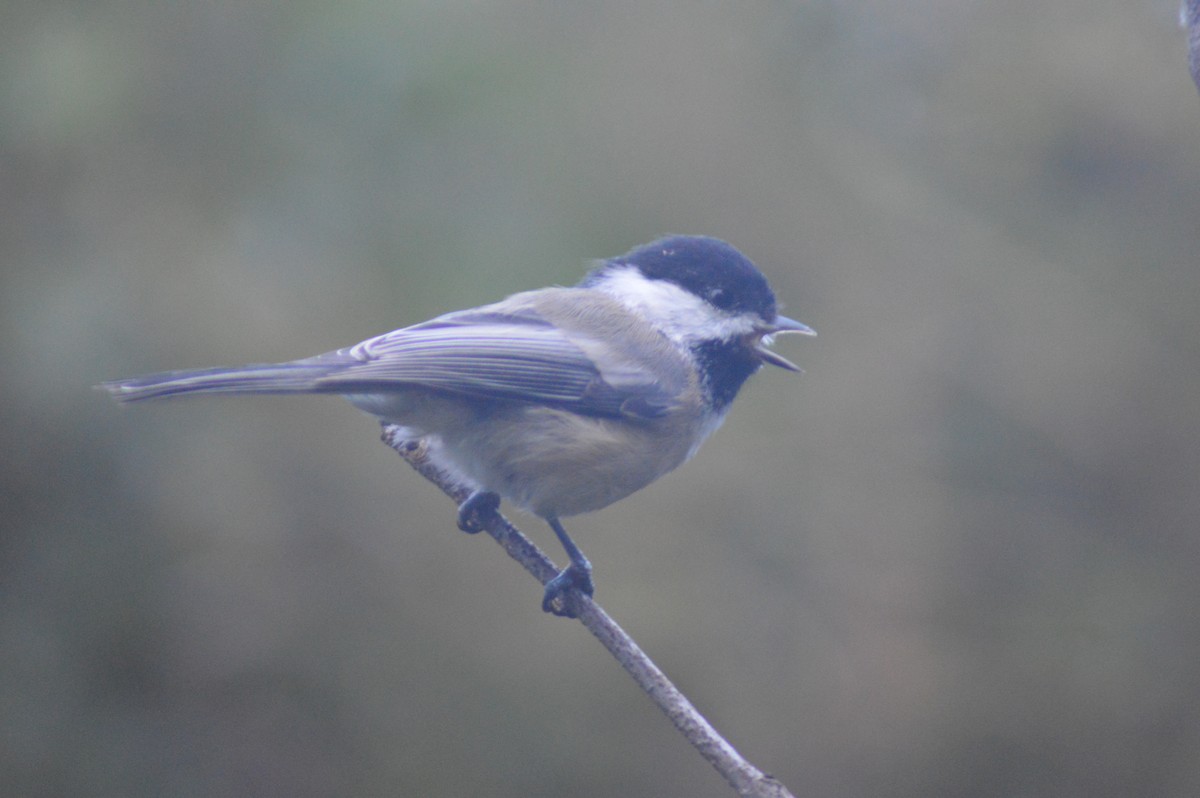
xmin=594 ymin=266 xmax=754 ymax=343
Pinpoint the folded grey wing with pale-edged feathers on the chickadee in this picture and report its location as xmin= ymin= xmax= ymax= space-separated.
xmin=316 ymin=306 xmax=676 ymax=418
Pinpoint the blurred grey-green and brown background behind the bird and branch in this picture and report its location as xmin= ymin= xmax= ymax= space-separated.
xmin=0 ymin=0 xmax=1200 ymax=797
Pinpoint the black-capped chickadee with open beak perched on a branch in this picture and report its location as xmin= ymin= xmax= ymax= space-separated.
xmin=103 ymin=235 xmax=816 ymax=617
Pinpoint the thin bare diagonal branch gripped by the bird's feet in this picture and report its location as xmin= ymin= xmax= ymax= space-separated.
xmin=383 ymin=424 xmax=794 ymax=798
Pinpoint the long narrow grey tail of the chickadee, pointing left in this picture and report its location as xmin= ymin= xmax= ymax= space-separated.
xmin=100 ymin=361 xmax=338 ymax=402
